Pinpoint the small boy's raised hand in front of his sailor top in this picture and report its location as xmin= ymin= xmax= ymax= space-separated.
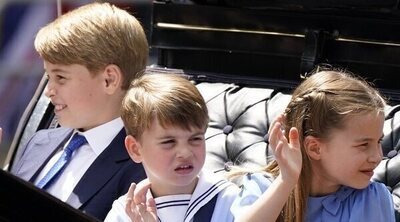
xmin=125 ymin=180 xmax=157 ymax=222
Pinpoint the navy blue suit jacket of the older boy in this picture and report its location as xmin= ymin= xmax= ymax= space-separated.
xmin=11 ymin=127 xmax=146 ymax=220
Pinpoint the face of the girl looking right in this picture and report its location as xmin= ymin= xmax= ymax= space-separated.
xmin=313 ymin=113 xmax=384 ymax=193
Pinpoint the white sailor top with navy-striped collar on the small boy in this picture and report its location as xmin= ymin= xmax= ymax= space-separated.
xmin=105 ymin=172 xmax=239 ymax=222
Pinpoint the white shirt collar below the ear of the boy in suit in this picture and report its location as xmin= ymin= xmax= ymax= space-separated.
xmin=79 ymin=117 xmax=124 ymax=156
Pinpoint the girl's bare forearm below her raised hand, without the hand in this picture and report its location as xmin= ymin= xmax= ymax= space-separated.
xmin=235 ymin=175 xmax=296 ymax=222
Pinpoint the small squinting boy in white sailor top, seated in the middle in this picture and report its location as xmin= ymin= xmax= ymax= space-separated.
xmin=105 ymin=74 xmax=239 ymax=222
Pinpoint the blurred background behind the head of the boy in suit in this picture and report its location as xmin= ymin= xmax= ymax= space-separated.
xmin=0 ymin=0 xmax=151 ymax=165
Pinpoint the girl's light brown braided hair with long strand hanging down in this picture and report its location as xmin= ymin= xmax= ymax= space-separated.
xmin=264 ymin=70 xmax=386 ymax=222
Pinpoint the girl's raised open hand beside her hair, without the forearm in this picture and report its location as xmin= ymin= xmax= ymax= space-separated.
xmin=269 ymin=114 xmax=302 ymax=184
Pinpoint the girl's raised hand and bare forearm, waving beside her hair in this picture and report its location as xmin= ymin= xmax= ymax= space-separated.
xmin=235 ymin=114 xmax=302 ymax=222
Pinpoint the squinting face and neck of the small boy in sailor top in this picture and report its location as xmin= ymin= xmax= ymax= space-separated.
xmin=128 ymin=119 xmax=206 ymax=196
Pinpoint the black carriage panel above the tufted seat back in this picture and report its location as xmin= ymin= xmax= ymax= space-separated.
xmin=151 ymin=1 xmax=400 ymax=100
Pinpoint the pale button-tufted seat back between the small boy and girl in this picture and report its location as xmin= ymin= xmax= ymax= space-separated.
xmin=197 ymin=82 xmax=290 ymax=171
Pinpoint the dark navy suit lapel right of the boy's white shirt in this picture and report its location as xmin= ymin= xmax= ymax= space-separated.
xmin=67 ymin=129 xmax=129 ymax=208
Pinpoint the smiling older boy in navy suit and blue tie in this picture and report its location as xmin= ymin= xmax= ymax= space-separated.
xmin=11 ymin=3 xmax=148 ymax=220
